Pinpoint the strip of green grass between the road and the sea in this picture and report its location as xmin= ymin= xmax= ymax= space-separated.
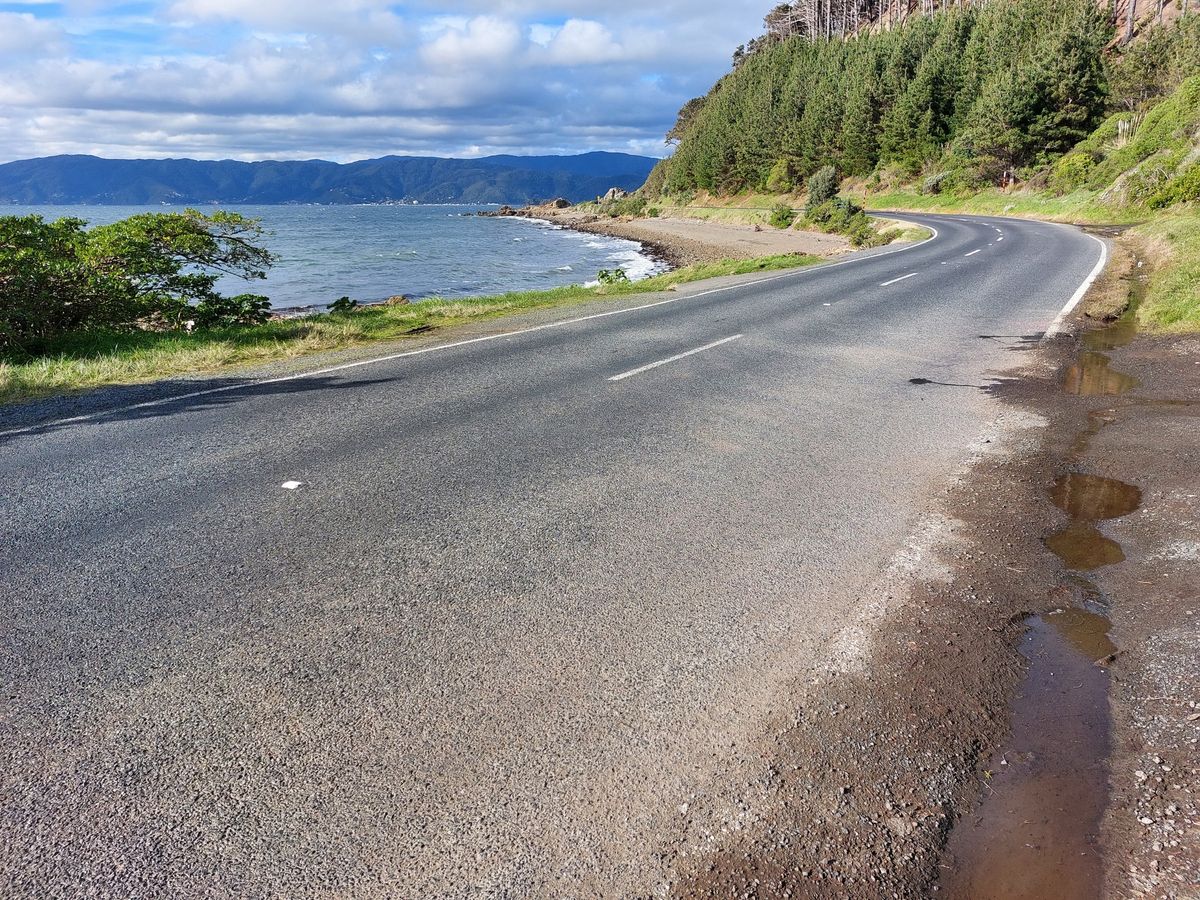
xmin=0 ymin=254 xmax=821 ymax=403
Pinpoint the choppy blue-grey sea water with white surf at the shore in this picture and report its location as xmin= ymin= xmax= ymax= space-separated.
xmin=0 ymin=205 xmax=662 ymax=308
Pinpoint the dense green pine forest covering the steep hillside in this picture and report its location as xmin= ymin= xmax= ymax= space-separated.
xmin=646 ymin=0 xmax=1200 ymax=199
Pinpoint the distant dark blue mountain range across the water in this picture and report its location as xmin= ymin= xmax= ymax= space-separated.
xmin=0 ymin=152 xmax=658 ymax=205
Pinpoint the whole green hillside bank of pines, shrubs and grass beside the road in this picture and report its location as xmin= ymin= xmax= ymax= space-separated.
xmin=642 ymin=0 xmax=1200 ymax=329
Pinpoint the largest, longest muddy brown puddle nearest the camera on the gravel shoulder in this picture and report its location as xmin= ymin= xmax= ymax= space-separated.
xmin=937 ymin=608 xmax=1116 ymax=900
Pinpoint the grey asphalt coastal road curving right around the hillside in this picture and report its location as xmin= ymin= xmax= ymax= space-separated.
xmin=0 ymin=216 xmax=1100 ymax=898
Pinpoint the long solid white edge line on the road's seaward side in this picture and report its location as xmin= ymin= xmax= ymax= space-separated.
xmin=0 ymin=217 xmax=940 ymax=437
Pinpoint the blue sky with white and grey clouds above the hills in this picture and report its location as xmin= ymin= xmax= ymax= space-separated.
xmin=0 ymin=0 xmax=772 ymax=162
